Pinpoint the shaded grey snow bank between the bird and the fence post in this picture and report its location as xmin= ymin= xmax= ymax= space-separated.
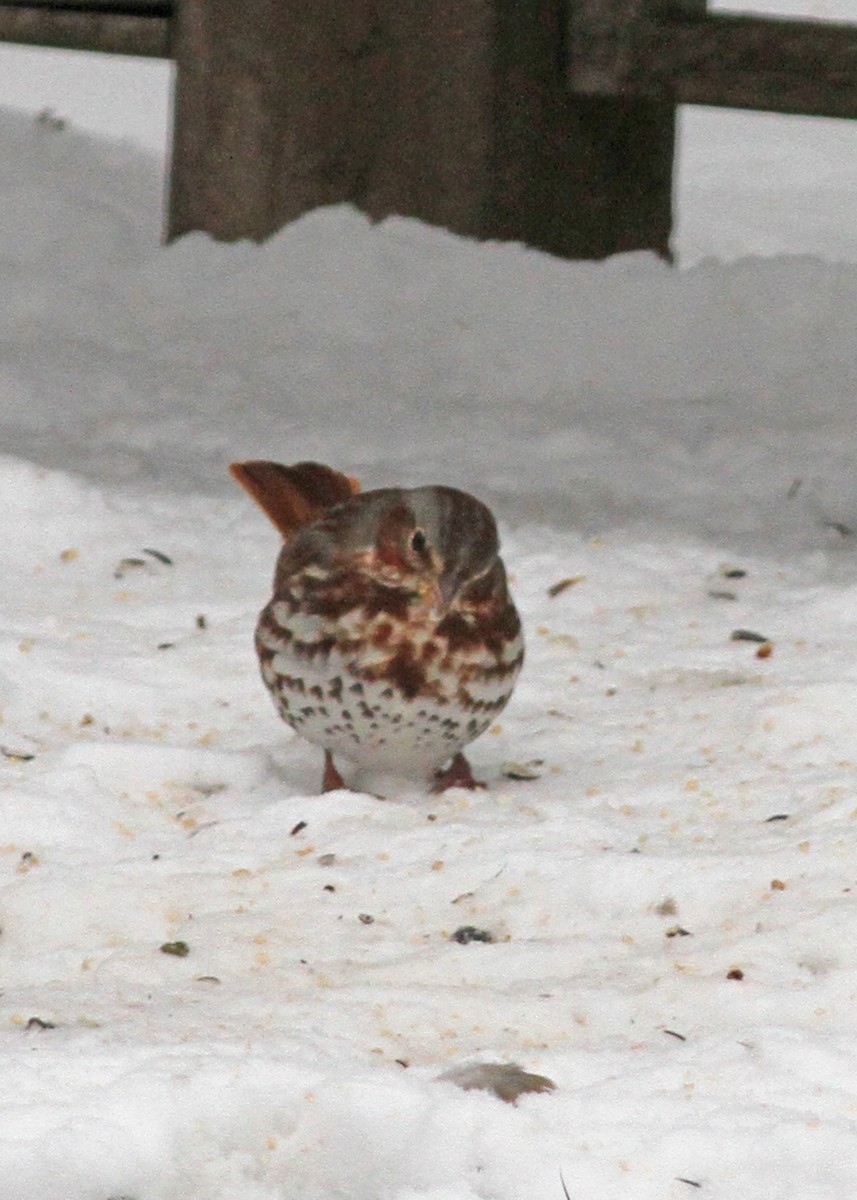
xmin=0 ymin=110 xmax=857 ymax=552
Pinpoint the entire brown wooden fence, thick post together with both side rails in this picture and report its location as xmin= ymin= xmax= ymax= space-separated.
xmin=0 ymin=0 xmax=857 ymax=258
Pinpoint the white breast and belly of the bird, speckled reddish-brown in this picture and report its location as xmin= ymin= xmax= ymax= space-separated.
xmin=256 ymin=600 xmax=523 ymax=775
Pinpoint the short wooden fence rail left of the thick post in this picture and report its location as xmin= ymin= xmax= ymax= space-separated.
xmin=0 ymin=5 xmax=172 ymax=59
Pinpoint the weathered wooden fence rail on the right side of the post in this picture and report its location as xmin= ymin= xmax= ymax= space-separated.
xmin=568 ymin=8 xmax=857 ymax=118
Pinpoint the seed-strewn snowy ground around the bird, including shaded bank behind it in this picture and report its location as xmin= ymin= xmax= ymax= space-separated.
xmin=0 ymin=72 xmax=857 ymax=1200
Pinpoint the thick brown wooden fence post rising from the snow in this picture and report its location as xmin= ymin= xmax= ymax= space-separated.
xmin=169 ymin=0 xmax=675 ymax=258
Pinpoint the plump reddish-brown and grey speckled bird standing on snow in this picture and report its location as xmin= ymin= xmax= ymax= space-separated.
xmin=230 ymin=462 xmax=523 ymax=791
